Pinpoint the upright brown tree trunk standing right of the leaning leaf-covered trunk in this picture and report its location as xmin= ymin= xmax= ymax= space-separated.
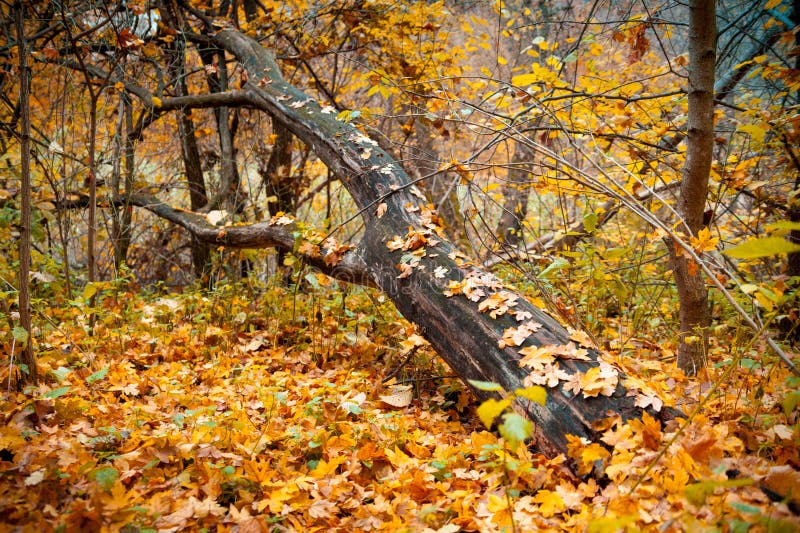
xmin=671 ymin=0 xmax=717 ymax=375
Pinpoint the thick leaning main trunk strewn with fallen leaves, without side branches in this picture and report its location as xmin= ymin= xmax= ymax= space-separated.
xmin=203 ymin=30 xmax=674 ymax=455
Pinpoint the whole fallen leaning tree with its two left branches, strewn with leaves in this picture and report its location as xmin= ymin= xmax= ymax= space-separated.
xmin=103 ymin=29 xmax=676 ymax=455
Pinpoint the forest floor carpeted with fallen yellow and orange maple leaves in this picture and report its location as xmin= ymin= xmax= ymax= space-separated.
xmin=0 ymin=275 xmax=800 ymax=533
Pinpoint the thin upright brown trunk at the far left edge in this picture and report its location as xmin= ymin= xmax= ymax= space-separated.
xmin=14 ymin=2 xmax=38 ymax=384
